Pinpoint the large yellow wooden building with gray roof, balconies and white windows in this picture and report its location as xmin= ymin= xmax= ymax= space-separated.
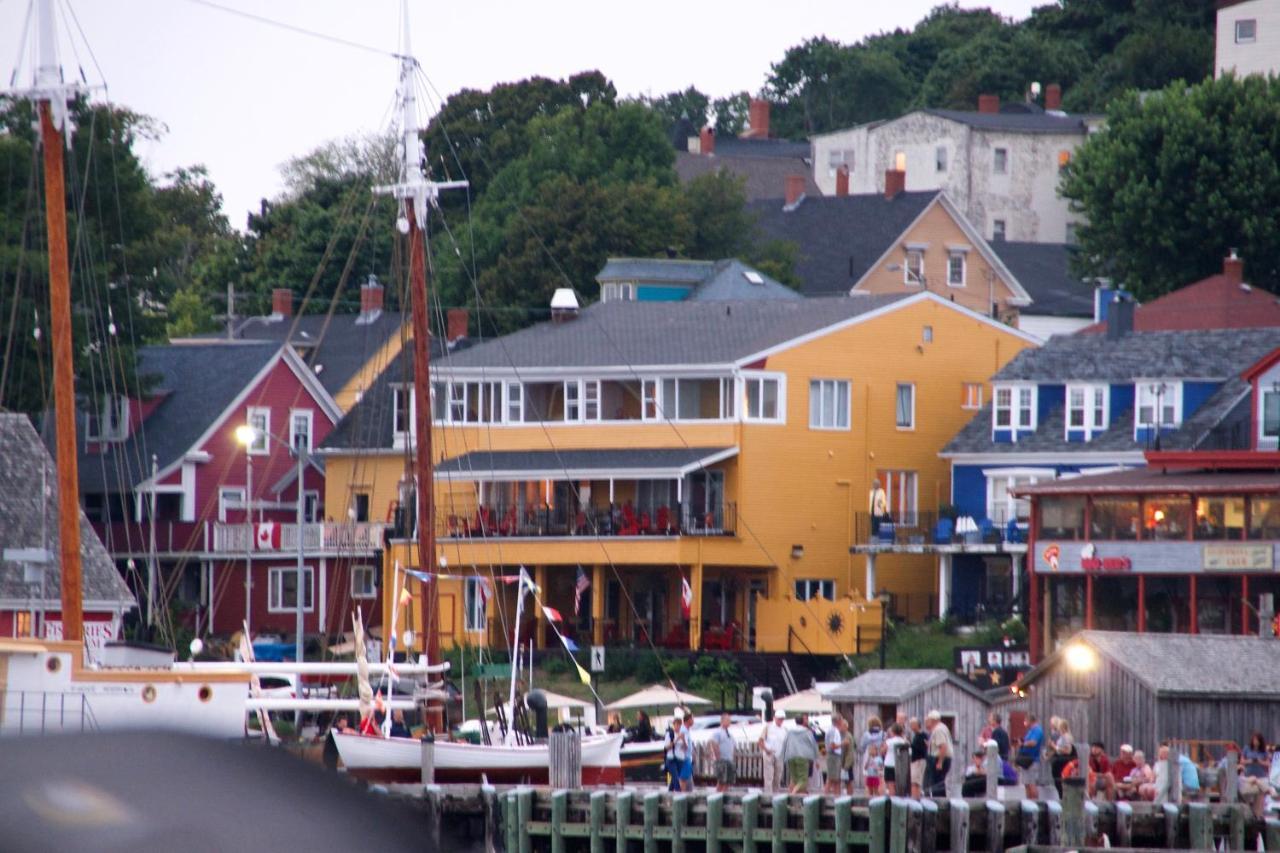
xmin=314 ymin=292 xmax=1036 ymax=653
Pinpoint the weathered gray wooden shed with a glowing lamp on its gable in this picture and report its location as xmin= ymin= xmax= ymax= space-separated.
xmin=1019 ymin=631 xmax=1280 ymax=756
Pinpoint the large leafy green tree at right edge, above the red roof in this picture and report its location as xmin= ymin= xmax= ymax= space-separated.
xmin=1061 ymin=76 xmax=1280 ymax=298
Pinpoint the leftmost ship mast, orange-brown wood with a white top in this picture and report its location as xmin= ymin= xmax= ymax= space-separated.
xmin=36 ymin=0 xmax=84 ymax=643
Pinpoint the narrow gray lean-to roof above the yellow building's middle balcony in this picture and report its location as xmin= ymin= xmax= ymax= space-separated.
xmin=435 ymin=447 xmax=732 ymax=479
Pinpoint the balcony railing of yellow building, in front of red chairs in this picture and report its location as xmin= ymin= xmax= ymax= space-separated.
xmin=409 ymin=502 xmax=737 ymax=539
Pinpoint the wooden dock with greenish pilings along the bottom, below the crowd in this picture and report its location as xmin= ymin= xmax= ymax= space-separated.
xmin=397 ymin=785 xmax=1280 ymax=853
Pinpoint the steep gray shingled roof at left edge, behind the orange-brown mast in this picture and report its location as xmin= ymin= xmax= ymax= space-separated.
xmin=0 ymin=414 xmax=137 ymax=610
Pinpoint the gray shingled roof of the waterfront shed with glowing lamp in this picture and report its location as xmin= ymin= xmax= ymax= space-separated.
xmin=1023 ymin=631 xmax=1280 ymax=699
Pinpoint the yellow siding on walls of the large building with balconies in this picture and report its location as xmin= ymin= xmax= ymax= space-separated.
xmin=326 ymin=297 xmax=1029 ymax=651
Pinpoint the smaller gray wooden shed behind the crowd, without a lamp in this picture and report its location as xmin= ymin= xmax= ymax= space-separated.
xmin=826 ymin=670 xmax=988 ymax=758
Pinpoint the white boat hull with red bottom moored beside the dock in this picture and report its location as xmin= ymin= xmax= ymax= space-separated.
xmin=333 ymin=733 xmax=622 ymax=785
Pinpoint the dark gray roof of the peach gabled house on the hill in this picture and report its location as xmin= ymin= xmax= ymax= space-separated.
xmin=749 ymin=190 xmax=940 ymax=296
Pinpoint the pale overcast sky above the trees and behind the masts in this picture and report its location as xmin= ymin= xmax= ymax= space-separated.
xmin=0 ymin=0 xmax=1046 ymax=228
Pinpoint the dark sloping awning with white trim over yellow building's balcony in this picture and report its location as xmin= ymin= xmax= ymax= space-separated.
xmin=435 ymin=447 xmax=737 ymax=483
